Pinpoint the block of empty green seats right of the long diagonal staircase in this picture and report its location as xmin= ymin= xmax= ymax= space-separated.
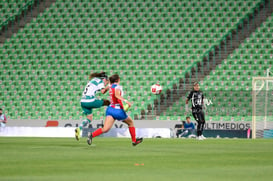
xmin=160 ymin=14 xmax=273 ymax=121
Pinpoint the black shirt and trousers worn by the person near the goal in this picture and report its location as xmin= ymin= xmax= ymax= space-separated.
xmin=187 ymin=90 xmax=205 ymax=137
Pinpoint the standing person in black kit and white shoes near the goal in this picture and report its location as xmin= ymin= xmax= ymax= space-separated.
xmin=186 ymin=82 xmax=206 ymax=140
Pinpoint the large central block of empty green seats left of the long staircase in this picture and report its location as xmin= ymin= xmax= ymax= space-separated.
xmin=0 ymin=0 xmax=264 ymax=119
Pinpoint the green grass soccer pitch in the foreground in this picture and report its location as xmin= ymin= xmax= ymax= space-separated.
xmin=0 ymin=137 xmax=273 ymax=181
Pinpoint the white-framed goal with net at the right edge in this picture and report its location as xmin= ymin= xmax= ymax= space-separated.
xmin=252 ymin=77 xmax=273 ymax=139
